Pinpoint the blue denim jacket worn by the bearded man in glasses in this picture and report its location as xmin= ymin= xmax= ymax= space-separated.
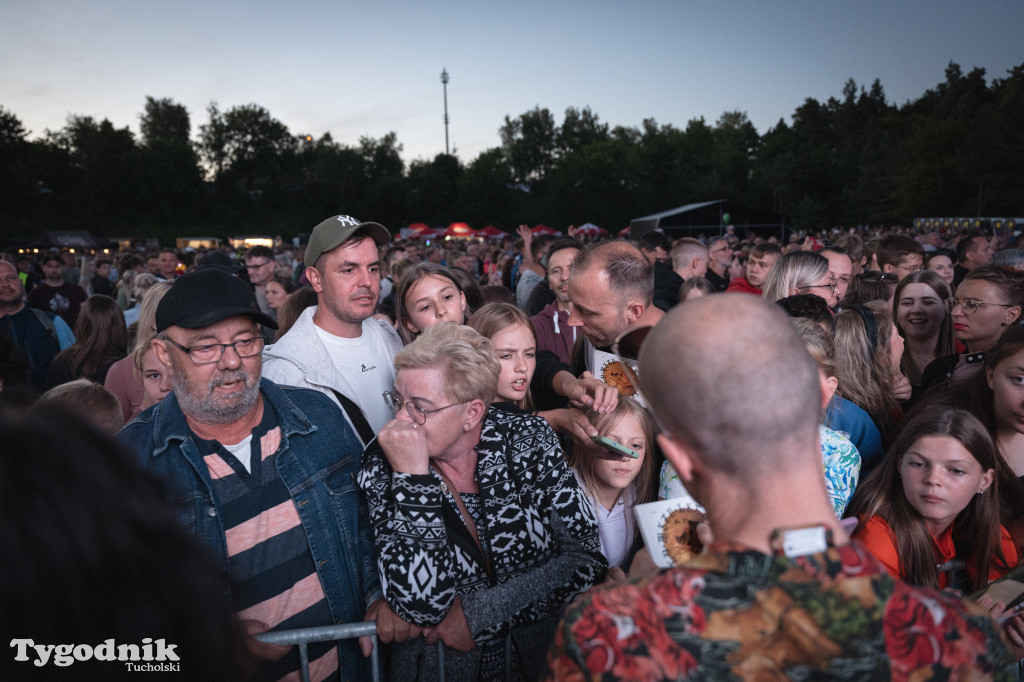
xmin=118 ymin=379 xmax=383 ymax=679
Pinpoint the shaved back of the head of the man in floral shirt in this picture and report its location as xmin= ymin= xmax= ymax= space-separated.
xmin=640 ymin=294 xmax=821 ymax=479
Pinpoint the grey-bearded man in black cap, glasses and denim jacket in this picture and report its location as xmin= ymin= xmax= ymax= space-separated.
xmin=118 ymin=268 xmax=411 ymax=679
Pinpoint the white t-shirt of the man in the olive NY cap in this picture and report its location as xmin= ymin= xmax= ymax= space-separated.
xmin=315 ymin=327 xmax=394 ymax=433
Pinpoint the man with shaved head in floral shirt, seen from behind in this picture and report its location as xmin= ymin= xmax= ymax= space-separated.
xmin=549 ymin=293 xmax=1024 ymax=680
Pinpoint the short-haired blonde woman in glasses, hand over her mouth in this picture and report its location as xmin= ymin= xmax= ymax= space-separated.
xmin=357 ymin=323 xmax=607 ymax=680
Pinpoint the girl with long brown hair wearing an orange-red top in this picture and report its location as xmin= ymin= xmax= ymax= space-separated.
xmin=850 ymin=407 xmax=1018 ymax=592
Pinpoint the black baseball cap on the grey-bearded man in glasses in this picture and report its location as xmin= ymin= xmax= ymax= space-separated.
xmin=157 ymin=267 xmax=278 ymax=332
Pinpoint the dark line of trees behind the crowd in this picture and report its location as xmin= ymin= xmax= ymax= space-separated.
xmin=0 ymin=62 xmax=1024 ymax=241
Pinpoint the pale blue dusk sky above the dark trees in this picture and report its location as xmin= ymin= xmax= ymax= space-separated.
xmin=0 ymin=0 xmax=1024 ymax=163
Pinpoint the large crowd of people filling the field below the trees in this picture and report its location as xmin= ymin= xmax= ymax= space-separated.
xmin=0 ymin=215 xmax=1024 ymax=680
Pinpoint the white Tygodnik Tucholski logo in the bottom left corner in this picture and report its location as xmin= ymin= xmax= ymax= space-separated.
xmin=10 ymin=637 xmax=181 ymax=672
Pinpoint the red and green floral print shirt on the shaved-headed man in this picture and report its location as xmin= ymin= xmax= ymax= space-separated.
xmin=547 ymin=542 xmax=1016 ymax=681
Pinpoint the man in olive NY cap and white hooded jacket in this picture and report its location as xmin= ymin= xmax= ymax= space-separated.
xmin=263 ymin=215 xmax=401 ymax=444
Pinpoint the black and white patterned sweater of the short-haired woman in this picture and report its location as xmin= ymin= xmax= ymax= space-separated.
xmin=358 ymin=408 xmax=607 ymax=668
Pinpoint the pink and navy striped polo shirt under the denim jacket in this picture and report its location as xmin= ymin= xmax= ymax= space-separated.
xmin=193 ymin=400 xmax=338 ymax=680
